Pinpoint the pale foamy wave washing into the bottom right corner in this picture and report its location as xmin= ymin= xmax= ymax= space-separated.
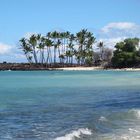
xmin=98 ymin=109 xmax=140 ymax=140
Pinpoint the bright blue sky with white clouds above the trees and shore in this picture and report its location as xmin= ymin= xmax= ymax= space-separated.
xmin=0 ymin=0 xmax=140 ymax=62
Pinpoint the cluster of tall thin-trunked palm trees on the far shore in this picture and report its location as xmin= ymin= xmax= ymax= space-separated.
xmin=20 ymin=29 xmax=111 ymax=65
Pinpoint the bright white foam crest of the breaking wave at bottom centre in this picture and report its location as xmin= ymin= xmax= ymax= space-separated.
xmin=55 ymin=128 xmax=92 ymax=140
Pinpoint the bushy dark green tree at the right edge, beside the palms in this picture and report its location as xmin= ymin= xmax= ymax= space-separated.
xmin=112 ymin=38 xmax=140 ymax=67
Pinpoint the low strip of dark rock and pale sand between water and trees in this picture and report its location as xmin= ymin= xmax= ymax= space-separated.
xmin=0 ymin=63 xmax=140 ymax=71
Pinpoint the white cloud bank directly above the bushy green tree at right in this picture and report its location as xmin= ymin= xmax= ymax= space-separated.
xmin=96 ymin=22 xmax=140 ymax=47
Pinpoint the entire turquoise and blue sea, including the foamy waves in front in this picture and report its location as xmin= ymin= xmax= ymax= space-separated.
xmin=0 ymin=71 xmax=140 ymax=140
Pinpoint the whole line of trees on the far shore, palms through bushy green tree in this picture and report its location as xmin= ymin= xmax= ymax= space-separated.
xmin=20 ymin=29 xmax=140 ymax=67
